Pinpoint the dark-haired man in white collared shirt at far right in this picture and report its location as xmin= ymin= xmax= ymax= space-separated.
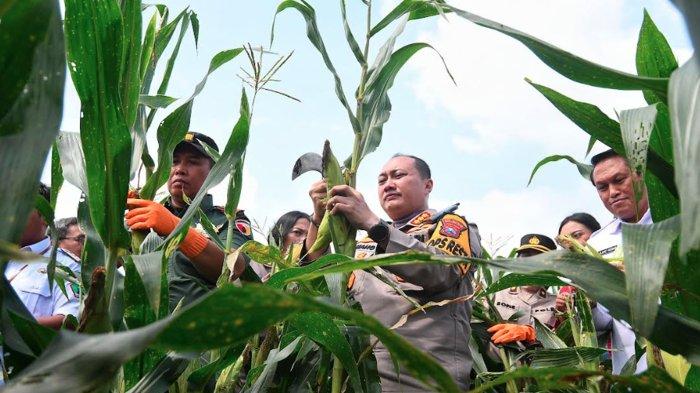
xmin=588 ymin=150 xmax=652 ymax=374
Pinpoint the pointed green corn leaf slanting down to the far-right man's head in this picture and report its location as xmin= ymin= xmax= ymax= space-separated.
xmin=528 ymin=81 xmax=678 ymax=195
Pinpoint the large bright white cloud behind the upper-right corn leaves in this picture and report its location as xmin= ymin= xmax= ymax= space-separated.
xmin=409 ymin=0 xmax=687 ymax=153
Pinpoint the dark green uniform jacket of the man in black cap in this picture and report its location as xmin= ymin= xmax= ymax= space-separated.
xmin=164 ymin=194 xmax=253 ymax=311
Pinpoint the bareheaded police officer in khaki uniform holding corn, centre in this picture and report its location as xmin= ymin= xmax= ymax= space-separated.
xmin=306 ymin=155 xmax=481 ymax=392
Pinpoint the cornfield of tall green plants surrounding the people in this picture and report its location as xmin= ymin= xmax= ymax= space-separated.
xmin=0 ymin=0 xmax=700 ymax=393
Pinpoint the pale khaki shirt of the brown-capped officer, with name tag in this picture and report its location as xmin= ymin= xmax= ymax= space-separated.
xmin=493 ymin=287 xmax=557 ymax=328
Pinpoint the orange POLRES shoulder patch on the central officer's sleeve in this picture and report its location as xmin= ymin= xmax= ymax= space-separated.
xmin=428 ymin=213 xmax=472 ymax=275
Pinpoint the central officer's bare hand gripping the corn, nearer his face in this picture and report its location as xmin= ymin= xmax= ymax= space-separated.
xmin=326 ymin=185 xmax=379 ymax=231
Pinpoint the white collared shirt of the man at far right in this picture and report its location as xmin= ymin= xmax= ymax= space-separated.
xmin=588 ymin=209 xmax=653 ymax=374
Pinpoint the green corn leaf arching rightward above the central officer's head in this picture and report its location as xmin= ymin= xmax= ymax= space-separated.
xmin=355 ymin=42 xmax=454 ymax=166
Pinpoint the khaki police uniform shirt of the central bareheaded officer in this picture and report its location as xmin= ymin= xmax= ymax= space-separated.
xmin=349 ymin=211 xmax=481 ymax=392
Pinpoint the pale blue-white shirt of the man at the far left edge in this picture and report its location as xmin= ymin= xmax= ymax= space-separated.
xmin=5 ymin=237 xmax=80 ymax=318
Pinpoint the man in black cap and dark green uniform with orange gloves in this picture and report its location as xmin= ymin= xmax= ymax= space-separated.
xmin=126 ymin=132 xmax=253 ymax=310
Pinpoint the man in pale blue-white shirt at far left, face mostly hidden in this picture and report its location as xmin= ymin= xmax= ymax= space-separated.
xmin=5 ymin=184 xmax=80 ymax=329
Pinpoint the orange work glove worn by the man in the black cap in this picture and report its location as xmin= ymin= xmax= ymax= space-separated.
xmin=125 ymin=198 xmax=209 ymax=258
